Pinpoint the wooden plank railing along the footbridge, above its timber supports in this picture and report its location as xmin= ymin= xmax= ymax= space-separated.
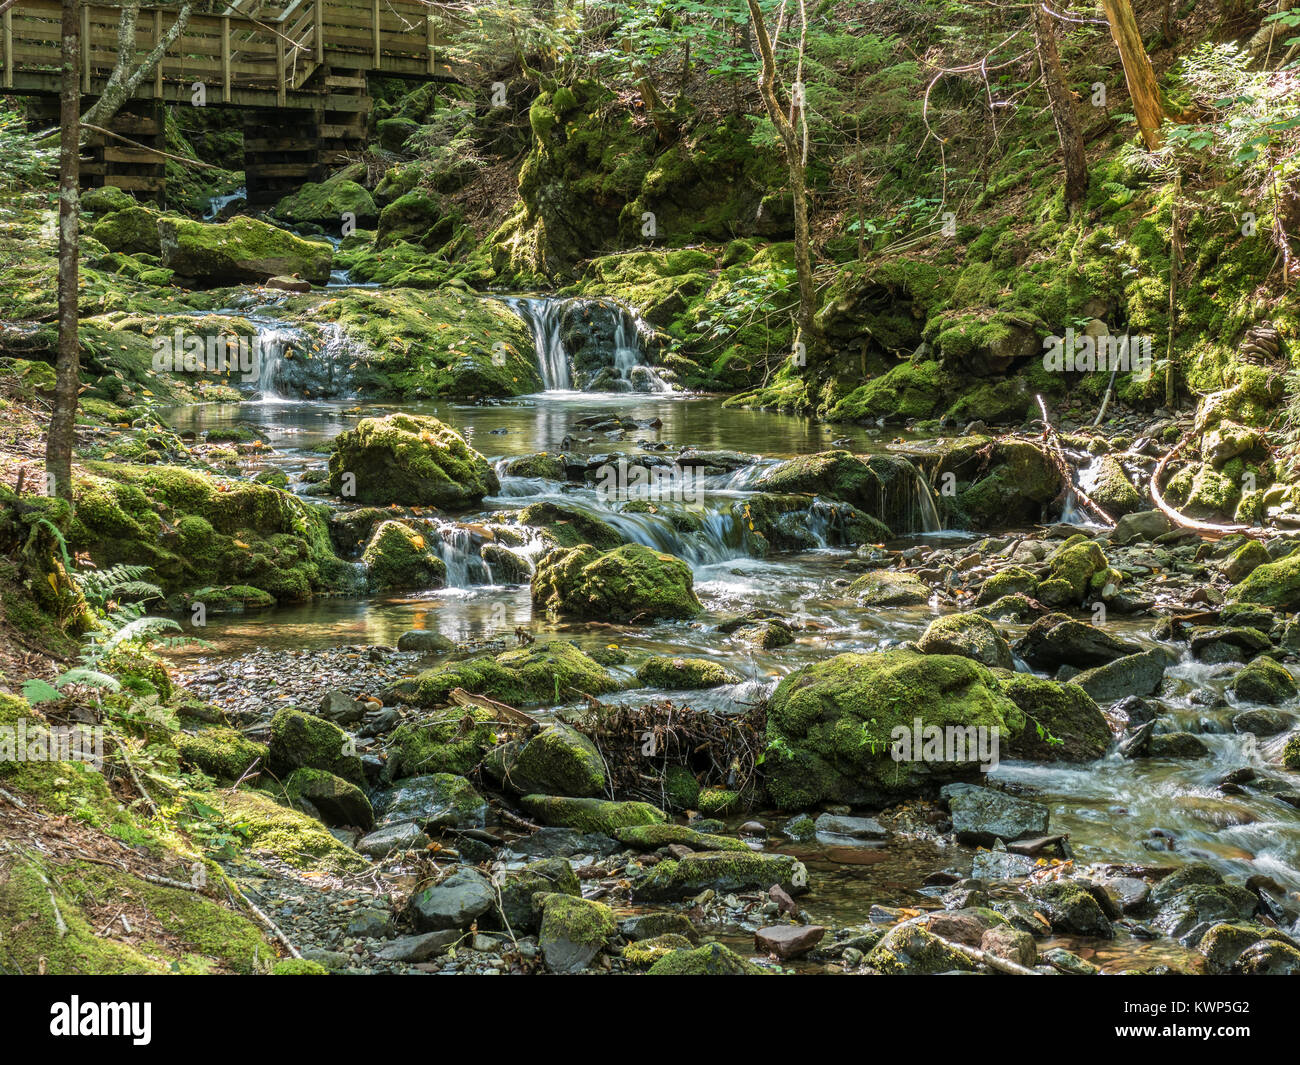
xmin=0 ymin=0 xmax=451 ymax=107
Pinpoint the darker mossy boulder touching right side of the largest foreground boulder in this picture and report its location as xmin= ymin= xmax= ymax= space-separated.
xmin=996 ymin=671 xmax=1113 ymax=762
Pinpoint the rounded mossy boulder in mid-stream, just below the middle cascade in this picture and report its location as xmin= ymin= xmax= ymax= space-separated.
xmin=533 ymin=544 xmax=702 ymax=622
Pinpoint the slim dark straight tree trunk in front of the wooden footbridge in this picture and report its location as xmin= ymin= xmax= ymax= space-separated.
xmin=46 ymin=0 xmax=82 ymax=502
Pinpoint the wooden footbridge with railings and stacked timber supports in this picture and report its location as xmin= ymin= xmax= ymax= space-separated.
xmin=0 ymin=0 xmax=458 ymax=203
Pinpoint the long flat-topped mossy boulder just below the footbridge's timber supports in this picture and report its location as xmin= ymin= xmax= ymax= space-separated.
xmin=159 ymin=216 xmax=334 ymax=286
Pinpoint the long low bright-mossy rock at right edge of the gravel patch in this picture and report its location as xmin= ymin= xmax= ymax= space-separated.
xmin=393 ymin=640 xmax=619 ymax=706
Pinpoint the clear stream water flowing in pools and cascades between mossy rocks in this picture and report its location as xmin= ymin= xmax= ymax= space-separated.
xmin=157 ymin=296 xmax=1300 ymax=967
